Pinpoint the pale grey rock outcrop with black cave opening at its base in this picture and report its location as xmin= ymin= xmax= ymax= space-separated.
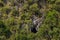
xmin=31 ymin=15 xmax=44 ymax=33
